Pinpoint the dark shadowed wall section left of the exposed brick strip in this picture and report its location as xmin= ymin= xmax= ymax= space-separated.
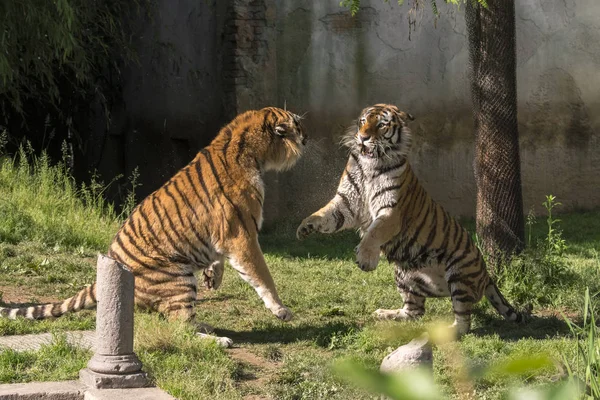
xmin=89 ymin=0 xmax=229 ymax=198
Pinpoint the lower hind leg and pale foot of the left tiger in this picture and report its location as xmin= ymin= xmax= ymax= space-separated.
xmin=148 ymin=275 xmax=233 ymax=347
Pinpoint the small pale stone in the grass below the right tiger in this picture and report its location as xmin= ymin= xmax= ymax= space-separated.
xmin=379 ymin=334 xmax=433 ymax=372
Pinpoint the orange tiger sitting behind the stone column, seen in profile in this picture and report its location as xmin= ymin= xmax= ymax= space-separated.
xmin=0 ymin=107 xmax=307 ymax=346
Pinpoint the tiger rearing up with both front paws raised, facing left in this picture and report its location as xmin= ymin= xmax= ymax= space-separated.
xmin=297 ymin=104 xmax=522 ymax=335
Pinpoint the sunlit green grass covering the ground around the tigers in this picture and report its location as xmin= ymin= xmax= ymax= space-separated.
xmin=0 ymin=149 xmax=600 ymax=400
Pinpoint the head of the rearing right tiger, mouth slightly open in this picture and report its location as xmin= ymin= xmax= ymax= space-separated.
xmin=344 ymin=104 xmax=414 ymax=160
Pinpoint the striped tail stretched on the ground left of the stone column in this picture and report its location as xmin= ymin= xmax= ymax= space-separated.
xmin=0 ymin=283 xmax=97 ymax=319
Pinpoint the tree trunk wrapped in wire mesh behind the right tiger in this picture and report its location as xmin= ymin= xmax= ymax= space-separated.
xmin=466 ymin=0 xmax=524 ymax=271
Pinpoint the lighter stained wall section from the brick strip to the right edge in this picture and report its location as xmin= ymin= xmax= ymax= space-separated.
xmin=236 ymin=0 xmax=600 ymax=219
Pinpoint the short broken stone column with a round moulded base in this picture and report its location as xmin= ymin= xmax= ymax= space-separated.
xmin=79 ymin=254 xmax=147 ymax=389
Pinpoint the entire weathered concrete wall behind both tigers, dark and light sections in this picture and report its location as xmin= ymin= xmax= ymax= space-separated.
xmin=89 ymin=0 xmax=600 ymax=221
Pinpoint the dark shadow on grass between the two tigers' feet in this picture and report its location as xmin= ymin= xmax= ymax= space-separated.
xmin=215 ymin=321 xmax=361 ymax=347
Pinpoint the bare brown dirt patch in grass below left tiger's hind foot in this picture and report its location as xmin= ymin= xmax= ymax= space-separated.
xmin=227 ymin=347 xmax=278 ymax=400
